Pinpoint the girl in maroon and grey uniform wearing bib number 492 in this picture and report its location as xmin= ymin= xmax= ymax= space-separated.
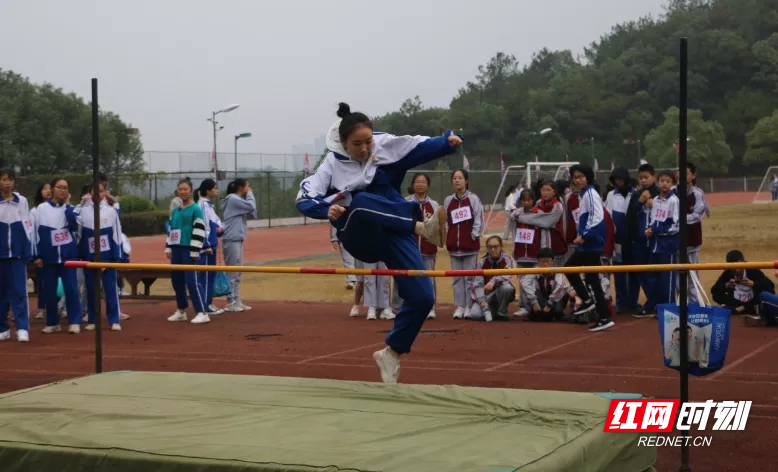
xmin=443 ymin=169 xmax=484 ymax=319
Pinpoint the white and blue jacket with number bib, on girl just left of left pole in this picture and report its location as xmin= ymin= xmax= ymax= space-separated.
xmin=33 ymin=200 xmax=80 ymax=265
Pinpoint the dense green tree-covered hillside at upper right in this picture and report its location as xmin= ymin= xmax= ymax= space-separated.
xmin=375 ymin=0 xmax=778 ymax=175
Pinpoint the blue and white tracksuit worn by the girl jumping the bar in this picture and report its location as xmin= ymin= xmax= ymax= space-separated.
xmin=297 ymin=122 xmax=456 ymax=354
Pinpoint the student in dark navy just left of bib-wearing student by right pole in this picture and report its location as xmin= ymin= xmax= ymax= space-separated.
xmin=623 ymin=164 xmax=659 ymax=318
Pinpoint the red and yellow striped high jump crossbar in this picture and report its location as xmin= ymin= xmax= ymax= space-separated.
xmin=65 ymin=261 xmax=778 ymax=277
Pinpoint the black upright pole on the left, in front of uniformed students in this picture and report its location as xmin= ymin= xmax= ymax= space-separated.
xmin=91 ymin=79 xmax=103 ymax=374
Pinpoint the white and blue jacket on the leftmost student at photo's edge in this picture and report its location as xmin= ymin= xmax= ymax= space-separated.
xmin=0 ymin=192 xmax=34 ymax=261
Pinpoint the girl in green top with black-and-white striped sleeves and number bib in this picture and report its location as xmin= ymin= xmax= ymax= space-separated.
xmin=165 ymin=179 xmax=211 ymax=324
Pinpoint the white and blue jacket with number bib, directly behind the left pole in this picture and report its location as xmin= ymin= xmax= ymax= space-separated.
xmin=77 ymin=200 xmax=123 ymax=262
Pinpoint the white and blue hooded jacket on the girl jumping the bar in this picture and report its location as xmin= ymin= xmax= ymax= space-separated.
xmin=296 ymin=121 xmax=456 ymax=220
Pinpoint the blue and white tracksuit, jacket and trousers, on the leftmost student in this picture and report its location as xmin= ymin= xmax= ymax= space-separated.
xmin=0 ymin=192 xmax=33 ymax=333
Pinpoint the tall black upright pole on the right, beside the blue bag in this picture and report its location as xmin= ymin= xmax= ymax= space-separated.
xmin=678 ymin=38 xmax=692 ymax=472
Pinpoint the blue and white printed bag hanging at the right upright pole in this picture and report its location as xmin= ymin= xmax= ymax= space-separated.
xmin=657 ymin=272 xmax=732 ymax=377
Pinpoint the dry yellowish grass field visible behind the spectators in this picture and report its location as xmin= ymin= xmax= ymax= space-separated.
xmin=146 ymin=204 xmax=778 ymax=304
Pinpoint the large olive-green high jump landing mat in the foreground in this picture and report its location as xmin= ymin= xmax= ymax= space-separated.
xmin=0 ymin=372 xmax=656 ymax=472
